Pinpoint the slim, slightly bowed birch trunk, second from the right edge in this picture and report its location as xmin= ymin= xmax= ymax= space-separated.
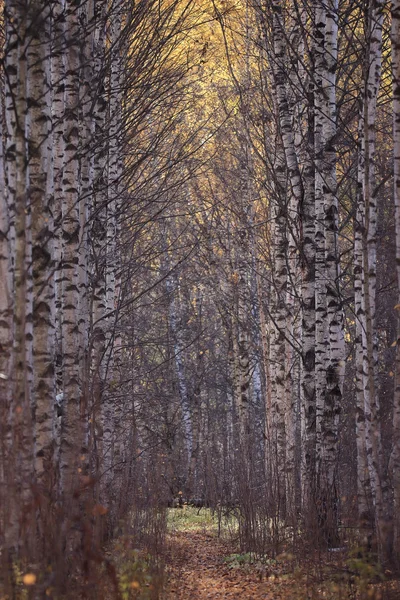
xmin=362 ymin=0 xmax=390 ymax=560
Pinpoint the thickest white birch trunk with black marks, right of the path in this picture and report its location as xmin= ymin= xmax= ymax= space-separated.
xmin=315 ymin=0 xmax=344 ymax=545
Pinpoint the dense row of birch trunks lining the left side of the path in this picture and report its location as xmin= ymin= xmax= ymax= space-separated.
xmin=0 ymin=1 xmax=129 ymax=576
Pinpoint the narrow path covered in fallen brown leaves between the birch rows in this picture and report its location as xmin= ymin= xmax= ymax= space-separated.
xmin=163 ymin=531 xmax=283 ymax=600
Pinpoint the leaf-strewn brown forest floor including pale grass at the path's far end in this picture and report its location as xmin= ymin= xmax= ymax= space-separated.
xmin=161 ymin=511 xmax=400 ymax=600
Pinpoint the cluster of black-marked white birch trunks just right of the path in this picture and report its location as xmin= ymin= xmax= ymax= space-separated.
xmin=260 ymin=2 xmax=344 ymax=545
